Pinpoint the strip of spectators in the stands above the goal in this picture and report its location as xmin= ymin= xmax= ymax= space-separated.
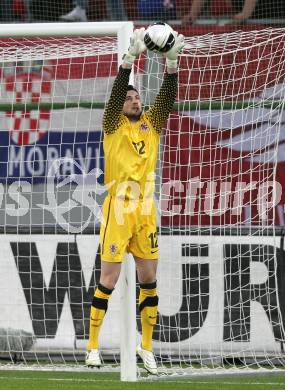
xmin=0 ymin=0 xmax=285 ymax=25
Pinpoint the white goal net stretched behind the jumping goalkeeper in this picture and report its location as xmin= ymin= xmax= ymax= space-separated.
xmin=0 ymin=23 xmax=285 ymax=374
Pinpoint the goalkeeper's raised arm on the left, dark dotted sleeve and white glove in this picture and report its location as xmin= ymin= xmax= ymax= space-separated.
xmin=103 ymin=28 xmax=146 ymax=134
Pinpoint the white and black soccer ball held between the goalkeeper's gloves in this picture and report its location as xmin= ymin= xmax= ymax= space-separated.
xmin=144 ymin=22 xmax=175 ymax=53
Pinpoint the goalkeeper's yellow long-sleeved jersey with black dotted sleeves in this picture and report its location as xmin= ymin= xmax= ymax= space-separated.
xmin=103 ymin=67 xmax=177 ymax=198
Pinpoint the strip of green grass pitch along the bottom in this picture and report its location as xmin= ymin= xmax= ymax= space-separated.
xmin=0 ymin=370 xmax=285 ymax=390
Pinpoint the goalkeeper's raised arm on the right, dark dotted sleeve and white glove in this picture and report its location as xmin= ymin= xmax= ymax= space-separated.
xmin=144 ymin=33 xmax=185 ymax=134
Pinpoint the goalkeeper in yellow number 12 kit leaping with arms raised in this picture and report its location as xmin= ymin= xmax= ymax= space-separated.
xmin=86 ymin=28 xmax=184 ymax=374
